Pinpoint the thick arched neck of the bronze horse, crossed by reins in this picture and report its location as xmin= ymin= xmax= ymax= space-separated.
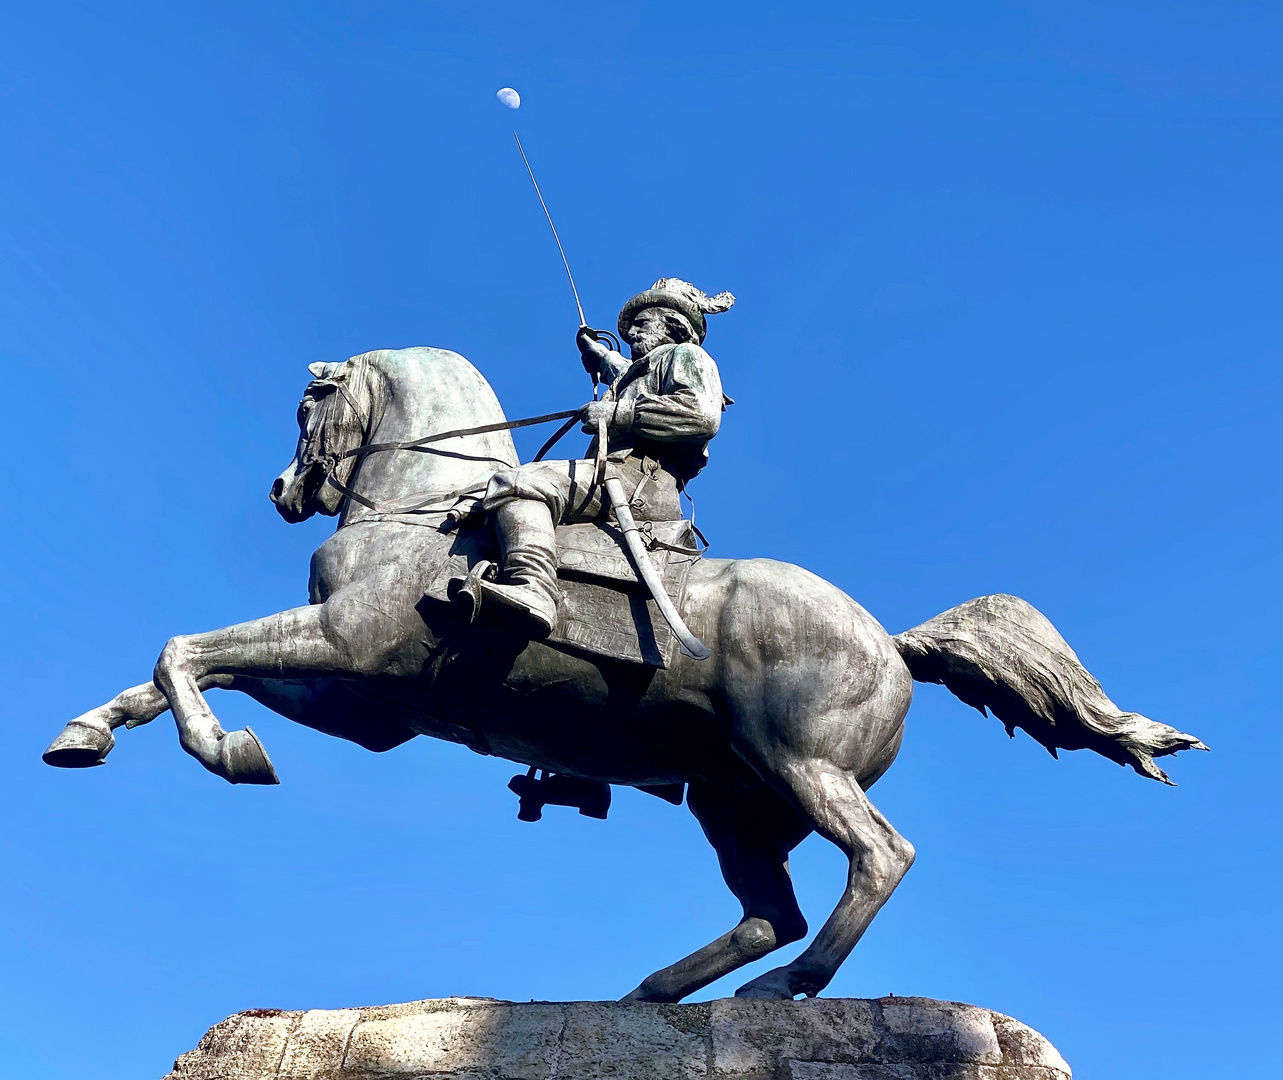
xmin=349 ymin=349 xmax=517 ymax=521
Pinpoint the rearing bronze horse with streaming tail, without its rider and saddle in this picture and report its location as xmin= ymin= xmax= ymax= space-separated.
xmin=37 ymin=348 xmax=1206 ymax=1002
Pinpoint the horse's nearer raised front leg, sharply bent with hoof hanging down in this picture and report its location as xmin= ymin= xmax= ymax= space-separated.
xmin=154 ymin=590 xmax=404 ymax=784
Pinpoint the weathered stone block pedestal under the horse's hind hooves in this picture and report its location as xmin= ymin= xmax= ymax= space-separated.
xmin=166 ymin=998 xmax=1070 ymax=1080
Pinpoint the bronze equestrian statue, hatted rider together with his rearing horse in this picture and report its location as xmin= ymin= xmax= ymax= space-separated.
xmin=44 ymin=256 xmax=1206 ymax=1002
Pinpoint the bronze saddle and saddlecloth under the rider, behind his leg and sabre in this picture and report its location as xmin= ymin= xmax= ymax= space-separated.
xmin=425 ymin=521 xmax=701 ymax=668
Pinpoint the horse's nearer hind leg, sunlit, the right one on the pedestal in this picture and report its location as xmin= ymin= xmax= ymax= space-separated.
xmin=736 ymin=759 xmax=913 ymax=999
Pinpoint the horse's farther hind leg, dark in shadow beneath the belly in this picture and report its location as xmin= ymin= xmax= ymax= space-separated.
xmin=625 ymin=784 xmax=811 ymax=1002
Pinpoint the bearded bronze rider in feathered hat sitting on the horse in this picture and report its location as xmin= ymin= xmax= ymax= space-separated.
xmin=481 ymin=277 xmax=735 ymax=637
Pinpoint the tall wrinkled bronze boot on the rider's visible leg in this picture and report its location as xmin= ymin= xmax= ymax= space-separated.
xmin=481 ymin=499 xmax=558 ymax=637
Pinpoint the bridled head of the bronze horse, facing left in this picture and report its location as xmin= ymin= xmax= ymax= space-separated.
xmin=268 ymin=357 xmax=368 ymax=525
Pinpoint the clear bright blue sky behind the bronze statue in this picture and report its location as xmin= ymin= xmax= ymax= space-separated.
xmin=0 ymin=0 xmax=1283 ymax=1080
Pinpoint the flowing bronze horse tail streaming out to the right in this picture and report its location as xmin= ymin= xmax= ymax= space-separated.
xmin=893 ymin=594 xmax=1207 ymax=784
